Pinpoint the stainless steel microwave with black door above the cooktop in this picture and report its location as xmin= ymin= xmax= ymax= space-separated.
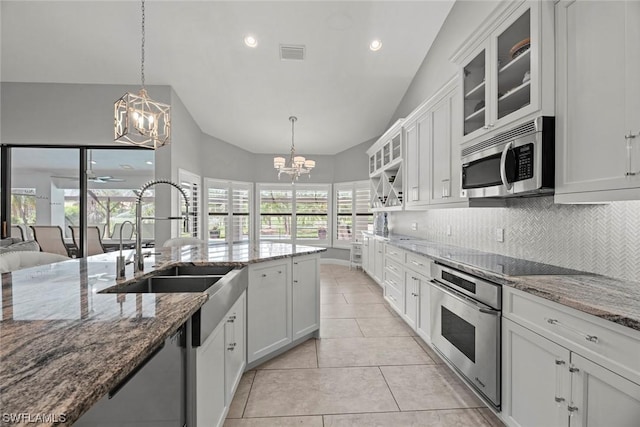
xmin=461 ymin=117 xmax=555 ymax=198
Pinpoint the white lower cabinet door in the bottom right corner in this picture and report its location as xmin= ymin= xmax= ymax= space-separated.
xmin=570 ymin=353 xmax=640 ymax=427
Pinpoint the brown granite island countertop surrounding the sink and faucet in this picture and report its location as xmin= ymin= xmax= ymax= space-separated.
xmin=0 ymin=243 xmax=326 ymax=425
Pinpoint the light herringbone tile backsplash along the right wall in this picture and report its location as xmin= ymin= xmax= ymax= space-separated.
xmin=389 ymin=197 xmax=640 ymax=281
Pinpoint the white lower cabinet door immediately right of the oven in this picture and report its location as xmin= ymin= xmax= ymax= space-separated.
xmin=502 ymin=318 xmax=572 ymax=427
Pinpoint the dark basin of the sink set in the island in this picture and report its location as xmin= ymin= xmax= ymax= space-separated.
xmin=102 ymin=275 xmax=224 ymax=294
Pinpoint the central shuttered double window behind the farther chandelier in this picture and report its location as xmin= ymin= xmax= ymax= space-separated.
xmin=258 ymin=184 xmax=331 ymax=246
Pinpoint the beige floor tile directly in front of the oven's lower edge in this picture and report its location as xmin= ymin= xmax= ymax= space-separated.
xmin=380 ymin=364 xmax=484 ymax=411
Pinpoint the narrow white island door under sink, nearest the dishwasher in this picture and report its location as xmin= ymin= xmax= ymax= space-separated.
xmin=196 ymin=323 xmax=226 ymax=426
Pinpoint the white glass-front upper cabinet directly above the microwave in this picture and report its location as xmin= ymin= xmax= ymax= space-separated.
xmin=452 ymin=1 xmax=554 ymax=143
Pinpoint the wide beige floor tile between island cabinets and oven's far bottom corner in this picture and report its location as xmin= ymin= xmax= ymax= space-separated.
xmin=318 ymin=337 xmax=433 ymax=368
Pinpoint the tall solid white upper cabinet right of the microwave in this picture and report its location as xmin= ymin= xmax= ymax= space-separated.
xmin=555 ymin=0 xmax=640 ymax=203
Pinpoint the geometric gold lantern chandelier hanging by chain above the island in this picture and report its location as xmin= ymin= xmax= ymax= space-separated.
xmin=114 ymin=0 xmax=171 ymax=150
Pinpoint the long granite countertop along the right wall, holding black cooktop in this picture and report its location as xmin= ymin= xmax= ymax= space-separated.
xmin=376 ymin=236 xmax=640 ymax=331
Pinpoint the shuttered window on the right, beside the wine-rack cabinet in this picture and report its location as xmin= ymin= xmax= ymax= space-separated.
xmin=333 ymin=181 xmax=373 ymax=247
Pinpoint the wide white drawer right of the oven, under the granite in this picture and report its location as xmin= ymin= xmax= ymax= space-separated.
xmin=502 ymin=287 xmax=640 ymax=384
